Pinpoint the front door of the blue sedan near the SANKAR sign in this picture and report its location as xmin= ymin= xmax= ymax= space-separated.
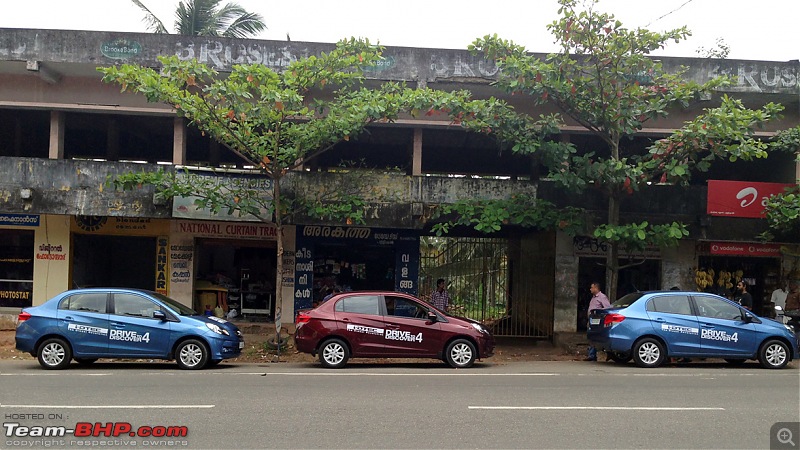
xmin=108 ymin=293 xmax=170 ymax=357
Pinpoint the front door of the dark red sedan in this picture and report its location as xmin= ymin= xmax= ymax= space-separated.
xmin=383 ymin=295 xmax=444 ymax=358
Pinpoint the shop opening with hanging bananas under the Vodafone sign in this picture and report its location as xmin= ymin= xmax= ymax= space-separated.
xmin=698 ymin=255 xmax=781 ymax=317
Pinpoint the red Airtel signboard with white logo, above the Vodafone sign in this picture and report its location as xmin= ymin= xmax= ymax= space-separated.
xmin=706 ymin=180 xmax=794 ymax=218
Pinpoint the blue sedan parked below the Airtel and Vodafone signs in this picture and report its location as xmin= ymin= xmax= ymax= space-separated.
xmin=587 ymin=291 xmax=798 ymax=369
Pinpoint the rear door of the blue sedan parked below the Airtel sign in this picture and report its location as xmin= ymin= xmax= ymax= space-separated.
xmin=646 ymin=294 xmax=700 ymax=355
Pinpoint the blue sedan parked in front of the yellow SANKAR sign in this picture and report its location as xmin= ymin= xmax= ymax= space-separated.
xmin=15 ymin=288 xmax=244 ymax=369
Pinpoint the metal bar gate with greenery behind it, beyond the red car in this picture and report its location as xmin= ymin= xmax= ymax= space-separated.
xmin=419 ymin=236 xmax=524 ymax=335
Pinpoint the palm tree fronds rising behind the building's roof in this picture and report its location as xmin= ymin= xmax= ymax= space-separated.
xmin=131 ymin=0 xmax=267 ymax=38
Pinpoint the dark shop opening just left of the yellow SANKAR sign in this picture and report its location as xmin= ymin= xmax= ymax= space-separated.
xmin=72 ymin=234 xmax=156 ymax=291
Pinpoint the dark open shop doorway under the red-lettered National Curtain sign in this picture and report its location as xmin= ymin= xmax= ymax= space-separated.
xmin=192 ymin=239 xmax=277 ymax=321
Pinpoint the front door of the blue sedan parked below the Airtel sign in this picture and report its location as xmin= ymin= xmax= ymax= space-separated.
xmin=694 ymin=295 xmax=756 ymax=357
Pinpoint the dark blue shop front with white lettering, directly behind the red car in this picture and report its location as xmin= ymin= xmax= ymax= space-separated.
xmin=294 ymin=225 xmax=419 ymax=310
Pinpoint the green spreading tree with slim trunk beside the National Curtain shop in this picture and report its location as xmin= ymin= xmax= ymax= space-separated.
xmin=98 ymin=39 xmax=410 ymax=320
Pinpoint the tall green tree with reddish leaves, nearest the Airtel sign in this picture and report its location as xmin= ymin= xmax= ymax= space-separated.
xmin=462 ymin=0 xmax=782 ymax=298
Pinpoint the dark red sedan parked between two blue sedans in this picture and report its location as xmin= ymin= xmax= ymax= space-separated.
xmin=294 ymin=292 xmax=494 ymax=368
